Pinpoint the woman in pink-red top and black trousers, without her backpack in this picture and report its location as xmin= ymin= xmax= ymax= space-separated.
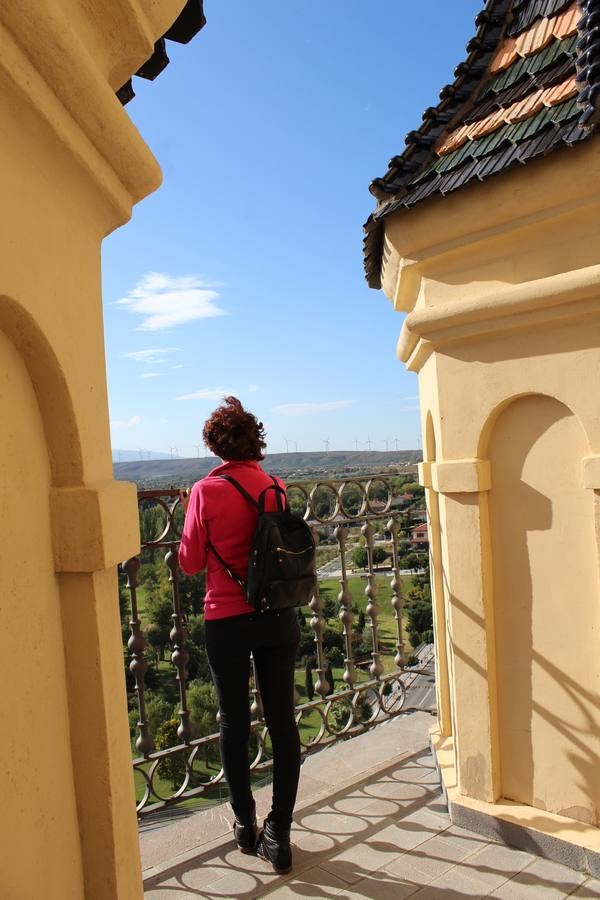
xmin=179 ymin=397 xmax=300 ymax=874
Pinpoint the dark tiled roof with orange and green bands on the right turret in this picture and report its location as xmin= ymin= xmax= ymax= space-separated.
xmin=364 ymin=0 xmax=600 ymax=288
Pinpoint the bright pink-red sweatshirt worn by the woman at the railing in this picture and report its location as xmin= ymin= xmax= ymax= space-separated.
xmin=179 ymin=461 xmax=285 ymax=619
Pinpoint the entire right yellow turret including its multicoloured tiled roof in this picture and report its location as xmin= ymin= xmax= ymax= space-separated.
xmin=365 ymin=0 xmax=600 ymax=874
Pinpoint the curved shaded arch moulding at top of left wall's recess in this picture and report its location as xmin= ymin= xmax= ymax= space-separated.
xmin=0 ymin=295 xmax=83 ymax=487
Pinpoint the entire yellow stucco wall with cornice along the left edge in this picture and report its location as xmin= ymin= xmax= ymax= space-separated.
xmin=0 ymin=0 xmax=184 ymax=900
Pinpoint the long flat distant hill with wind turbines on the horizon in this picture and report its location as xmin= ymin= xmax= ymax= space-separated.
xmin=114 ymin=450 xmax=422 ymax=486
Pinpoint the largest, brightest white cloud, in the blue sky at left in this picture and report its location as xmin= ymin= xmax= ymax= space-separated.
xmin=116 ymin=272 xmax=227 ymax=331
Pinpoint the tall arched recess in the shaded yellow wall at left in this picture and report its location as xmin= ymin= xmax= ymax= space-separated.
xmin=0 ymin=297 xmax=84 ymax=897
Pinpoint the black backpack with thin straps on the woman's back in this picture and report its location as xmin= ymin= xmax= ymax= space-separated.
xmin=208 ymin=475 xmax=317 ymax=612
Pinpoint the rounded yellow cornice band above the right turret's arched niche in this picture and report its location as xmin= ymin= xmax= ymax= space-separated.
xmin=397 ymin=265 xmax=600 ymax=371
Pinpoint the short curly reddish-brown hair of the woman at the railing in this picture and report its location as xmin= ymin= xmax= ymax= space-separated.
xmin=202 ymin=397 xmax=267 ymax=460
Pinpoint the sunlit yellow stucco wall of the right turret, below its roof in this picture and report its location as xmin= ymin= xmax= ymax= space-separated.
xmin=383 ymin=134 xmax=600 ymax=833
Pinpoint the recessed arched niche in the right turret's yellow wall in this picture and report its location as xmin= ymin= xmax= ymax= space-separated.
xmin=481 ymin=393 xmax=600 ymax=824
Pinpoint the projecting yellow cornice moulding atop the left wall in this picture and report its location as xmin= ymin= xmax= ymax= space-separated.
xmin=0 ymin=0 xmax=170 ymax=221
